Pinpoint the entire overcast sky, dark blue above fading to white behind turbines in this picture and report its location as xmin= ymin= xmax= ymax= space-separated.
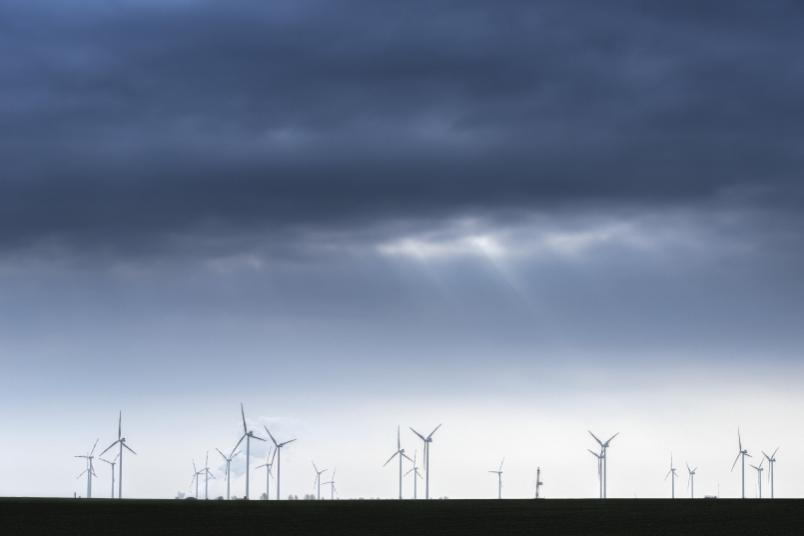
xmin=0 ymin=0 xmax=804 ymax=498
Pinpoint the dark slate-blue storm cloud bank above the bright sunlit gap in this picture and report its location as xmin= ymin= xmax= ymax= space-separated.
xmin=0 ymin=1 xmax=804 ymax=253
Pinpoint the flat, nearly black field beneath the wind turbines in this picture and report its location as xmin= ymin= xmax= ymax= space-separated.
xmin=0 ymin=499 xmax=804 ymax=536
